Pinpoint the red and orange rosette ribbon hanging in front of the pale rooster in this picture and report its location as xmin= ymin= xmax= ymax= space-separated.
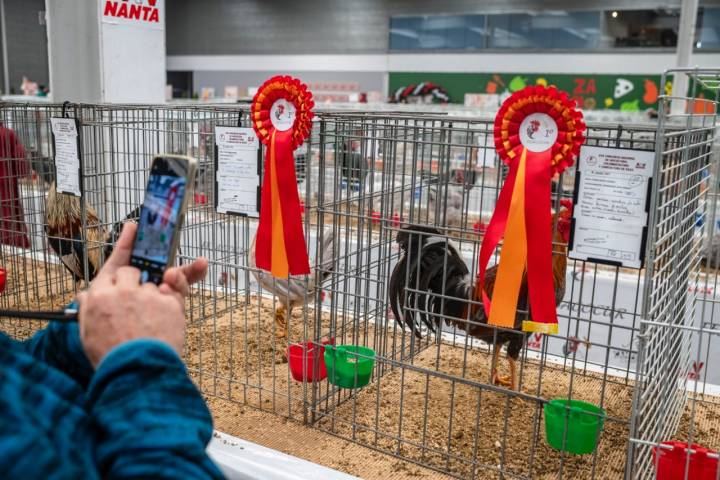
xmin=251 ymin=76 xmax=315 ymax=278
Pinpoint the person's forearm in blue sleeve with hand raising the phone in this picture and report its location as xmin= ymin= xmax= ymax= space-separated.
xmin=78 ymin=223 xmax=222 ymax=479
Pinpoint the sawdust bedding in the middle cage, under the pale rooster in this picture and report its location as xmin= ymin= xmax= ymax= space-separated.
xmin=185 ymin=295 xmax=410 ymax=418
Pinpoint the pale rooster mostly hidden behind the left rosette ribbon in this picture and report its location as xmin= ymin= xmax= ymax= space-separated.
xmin=248 ymin=228 xmax=337 ymax=348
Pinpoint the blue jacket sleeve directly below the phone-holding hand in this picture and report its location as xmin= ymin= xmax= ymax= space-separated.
xmin=86 ymin=340 xmax=223 ymax=479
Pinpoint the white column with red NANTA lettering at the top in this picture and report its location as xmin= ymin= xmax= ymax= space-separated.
xmin=45 ymin=0 xmax=165 ymax=103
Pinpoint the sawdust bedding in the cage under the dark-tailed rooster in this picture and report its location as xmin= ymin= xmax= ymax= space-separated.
xmin=312 ymin=345 xmax=632 ymax=479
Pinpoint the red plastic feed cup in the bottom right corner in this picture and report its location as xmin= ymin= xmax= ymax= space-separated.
xmin=653 ymin=442 xmax=718 ymax=480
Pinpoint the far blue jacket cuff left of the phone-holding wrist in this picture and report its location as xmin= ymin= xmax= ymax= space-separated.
xmin=20 ymin=322 xmax=94 ymax=388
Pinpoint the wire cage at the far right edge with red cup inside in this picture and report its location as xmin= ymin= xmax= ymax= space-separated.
xmin=626 ymin=69 xmax=720 ymax=479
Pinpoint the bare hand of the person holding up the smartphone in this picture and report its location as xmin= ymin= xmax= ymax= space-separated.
xmin=78 ymin=223 xmax=207 ymax=368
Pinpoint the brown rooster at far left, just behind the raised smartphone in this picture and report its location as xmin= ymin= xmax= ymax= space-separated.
xmin=45 ymin=182 xmax=140 ymax=283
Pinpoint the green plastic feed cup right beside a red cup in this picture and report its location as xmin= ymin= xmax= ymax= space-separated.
xmin=325 ymin=345 xmax=375 ymax=388
